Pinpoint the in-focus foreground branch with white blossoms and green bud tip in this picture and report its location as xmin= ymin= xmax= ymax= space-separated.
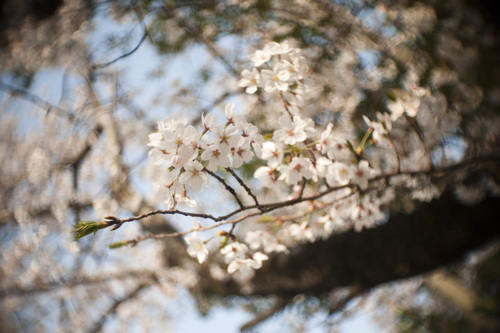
xmin=75 ymin=41 xmax=498 ymax=278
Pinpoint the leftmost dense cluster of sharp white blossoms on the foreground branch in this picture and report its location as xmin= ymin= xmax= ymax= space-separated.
xmin=148 ymin=103 xmax=264 ymax=209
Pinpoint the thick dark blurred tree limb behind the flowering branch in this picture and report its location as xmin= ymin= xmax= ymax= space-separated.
xmin=198 ymin=188 xmax=500 ymax=299
